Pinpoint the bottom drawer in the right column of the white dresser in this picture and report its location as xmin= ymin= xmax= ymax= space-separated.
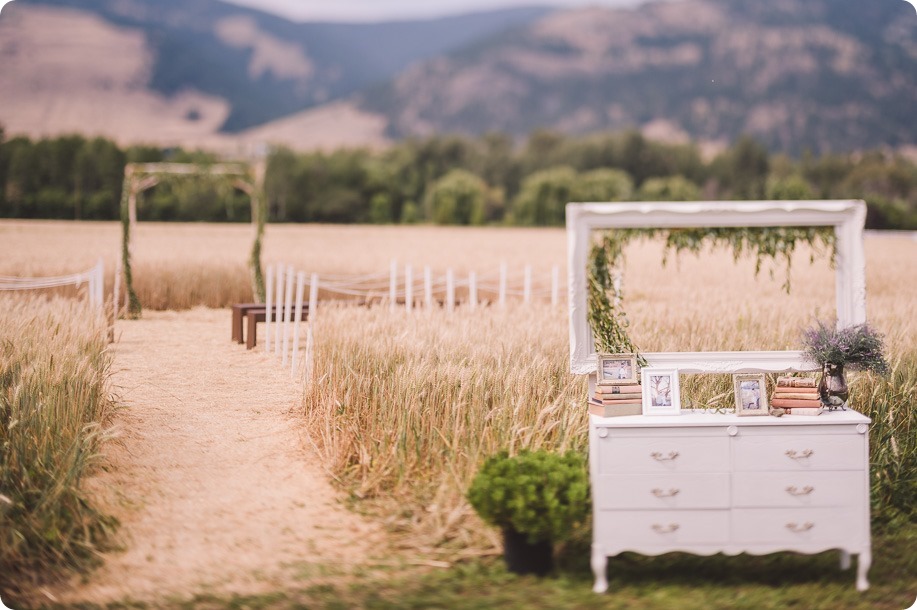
xmin=732 ymin=508 xmax=865 ymax=549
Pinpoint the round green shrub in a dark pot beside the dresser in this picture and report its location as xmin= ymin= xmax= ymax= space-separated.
xmin=468 ymin=451 xmax=591 ymax=576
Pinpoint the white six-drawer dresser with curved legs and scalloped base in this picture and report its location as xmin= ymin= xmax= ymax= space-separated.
xmin=589 ymin=411 xmax=872 ymax=593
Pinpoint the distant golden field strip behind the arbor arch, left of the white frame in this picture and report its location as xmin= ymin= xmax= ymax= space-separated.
xmin=0 ymin=220 xmax=566 ymax=310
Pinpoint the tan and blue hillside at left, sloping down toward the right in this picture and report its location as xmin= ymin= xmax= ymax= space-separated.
xmin=0 ymin=0 xmax=547 ymax=144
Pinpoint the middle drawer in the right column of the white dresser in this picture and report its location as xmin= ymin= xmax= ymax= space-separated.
xmin=732 ymin=471 xmax=866 ymax=508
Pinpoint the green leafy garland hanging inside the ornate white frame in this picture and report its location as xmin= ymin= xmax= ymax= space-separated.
xmin=587 ymin=227 xmax=837 ymax=356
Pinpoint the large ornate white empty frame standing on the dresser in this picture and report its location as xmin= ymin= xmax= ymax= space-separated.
xmin=566 ymin=200 xmax=866 ymax=375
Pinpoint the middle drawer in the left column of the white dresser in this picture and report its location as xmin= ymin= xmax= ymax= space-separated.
xmin=592 ymin=472 xmax=729 ymax=510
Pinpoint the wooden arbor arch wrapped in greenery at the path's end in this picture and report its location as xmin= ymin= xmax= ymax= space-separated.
xmin=121 ymin=163 xmax=267 ymax=317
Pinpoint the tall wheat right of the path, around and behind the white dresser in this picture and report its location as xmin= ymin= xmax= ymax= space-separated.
xmin=303 ymin=233 xmax=917 ymax=558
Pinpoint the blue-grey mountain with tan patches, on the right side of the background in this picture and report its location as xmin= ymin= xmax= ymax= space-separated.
xmin=360 ymin=0 xmax=917 ymax=153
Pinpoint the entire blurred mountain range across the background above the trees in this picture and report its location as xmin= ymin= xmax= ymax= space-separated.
xmin=0 ymin=0 xmax=917 ymax=154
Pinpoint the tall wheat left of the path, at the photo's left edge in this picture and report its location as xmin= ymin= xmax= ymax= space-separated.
xmin=0 ymin=294 xmax=113 ymax=592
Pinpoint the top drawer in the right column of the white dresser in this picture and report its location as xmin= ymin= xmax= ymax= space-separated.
xmin=732 ymin=434 xmax=866 ymax=472
